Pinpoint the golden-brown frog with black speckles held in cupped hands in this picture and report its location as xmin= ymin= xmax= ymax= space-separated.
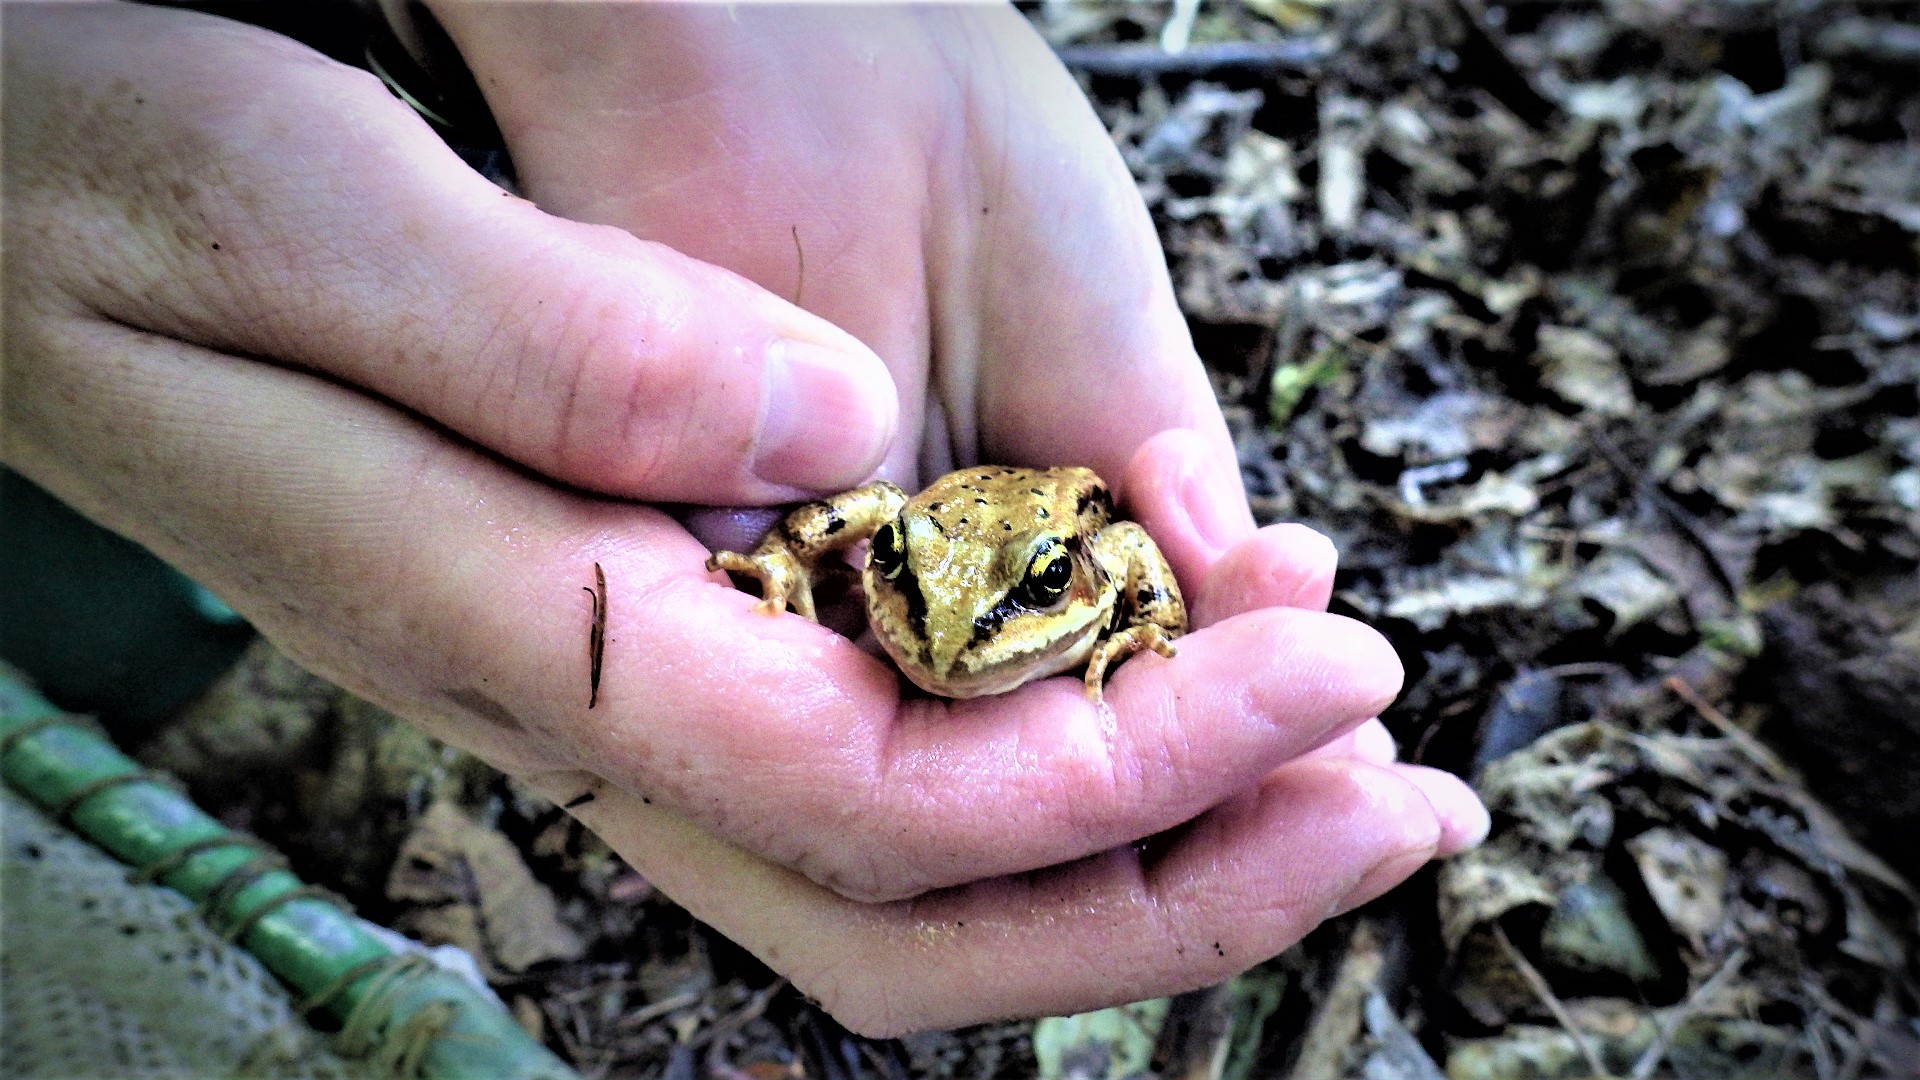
xmin=707 ymin=465 xmax=1187 ymax=705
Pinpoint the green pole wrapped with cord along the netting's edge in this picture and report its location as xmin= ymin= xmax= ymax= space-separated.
xmin=0 ymin=669 xmax=578 ymax=1080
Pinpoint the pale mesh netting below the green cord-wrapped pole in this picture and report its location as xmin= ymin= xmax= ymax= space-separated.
xmin=0 ymin=788 xmax=365 ymax=1080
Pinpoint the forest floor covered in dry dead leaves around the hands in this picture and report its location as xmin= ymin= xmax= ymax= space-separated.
xmin=144 ymin=0 xmax=1920 ymax=1080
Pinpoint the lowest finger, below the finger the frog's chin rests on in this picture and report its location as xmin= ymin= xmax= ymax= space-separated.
xmin=556 ymin=761 xmax=1440 ymax=1036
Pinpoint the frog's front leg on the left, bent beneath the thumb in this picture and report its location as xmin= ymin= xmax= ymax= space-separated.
xmin=707 ymin=480 xmax=906 ymax=623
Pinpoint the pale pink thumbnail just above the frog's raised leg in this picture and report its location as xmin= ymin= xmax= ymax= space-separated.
xmin=753 ymin=338 xmax=899 ymax=492
